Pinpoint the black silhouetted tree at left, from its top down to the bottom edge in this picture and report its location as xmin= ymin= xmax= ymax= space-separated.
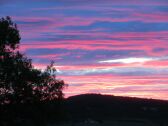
xmin=0 ymin=17 xmax=66 ymax=126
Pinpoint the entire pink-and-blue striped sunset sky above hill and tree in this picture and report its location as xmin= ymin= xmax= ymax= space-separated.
xmin=0 ymin=0 xmax=168 ymax=100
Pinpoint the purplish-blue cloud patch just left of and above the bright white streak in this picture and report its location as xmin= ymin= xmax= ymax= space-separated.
xmin=26 ymin=47 xmax=146 ymax=65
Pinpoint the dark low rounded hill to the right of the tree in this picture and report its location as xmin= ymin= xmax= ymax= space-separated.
xmin=65 ymin=94 xmax=168 ymax=125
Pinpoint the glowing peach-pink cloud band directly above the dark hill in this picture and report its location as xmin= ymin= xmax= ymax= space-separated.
xmin=62 ymin=76 xmax=168 ymax=99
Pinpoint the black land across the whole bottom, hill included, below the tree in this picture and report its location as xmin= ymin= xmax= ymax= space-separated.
xmin=0 ymin=94 xmax=168 ymax=126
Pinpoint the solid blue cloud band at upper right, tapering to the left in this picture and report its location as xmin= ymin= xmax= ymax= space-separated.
xmin=61 ymin=21 xmax=168 ymax=33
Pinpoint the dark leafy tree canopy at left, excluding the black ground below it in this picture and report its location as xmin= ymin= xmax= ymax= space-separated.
xmin=0 ymin=17 xmax=65 ymax=104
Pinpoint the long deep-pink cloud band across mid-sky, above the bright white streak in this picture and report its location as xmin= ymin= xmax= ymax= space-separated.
xmin=20 ymin=39 xmax=168 ymax=56
